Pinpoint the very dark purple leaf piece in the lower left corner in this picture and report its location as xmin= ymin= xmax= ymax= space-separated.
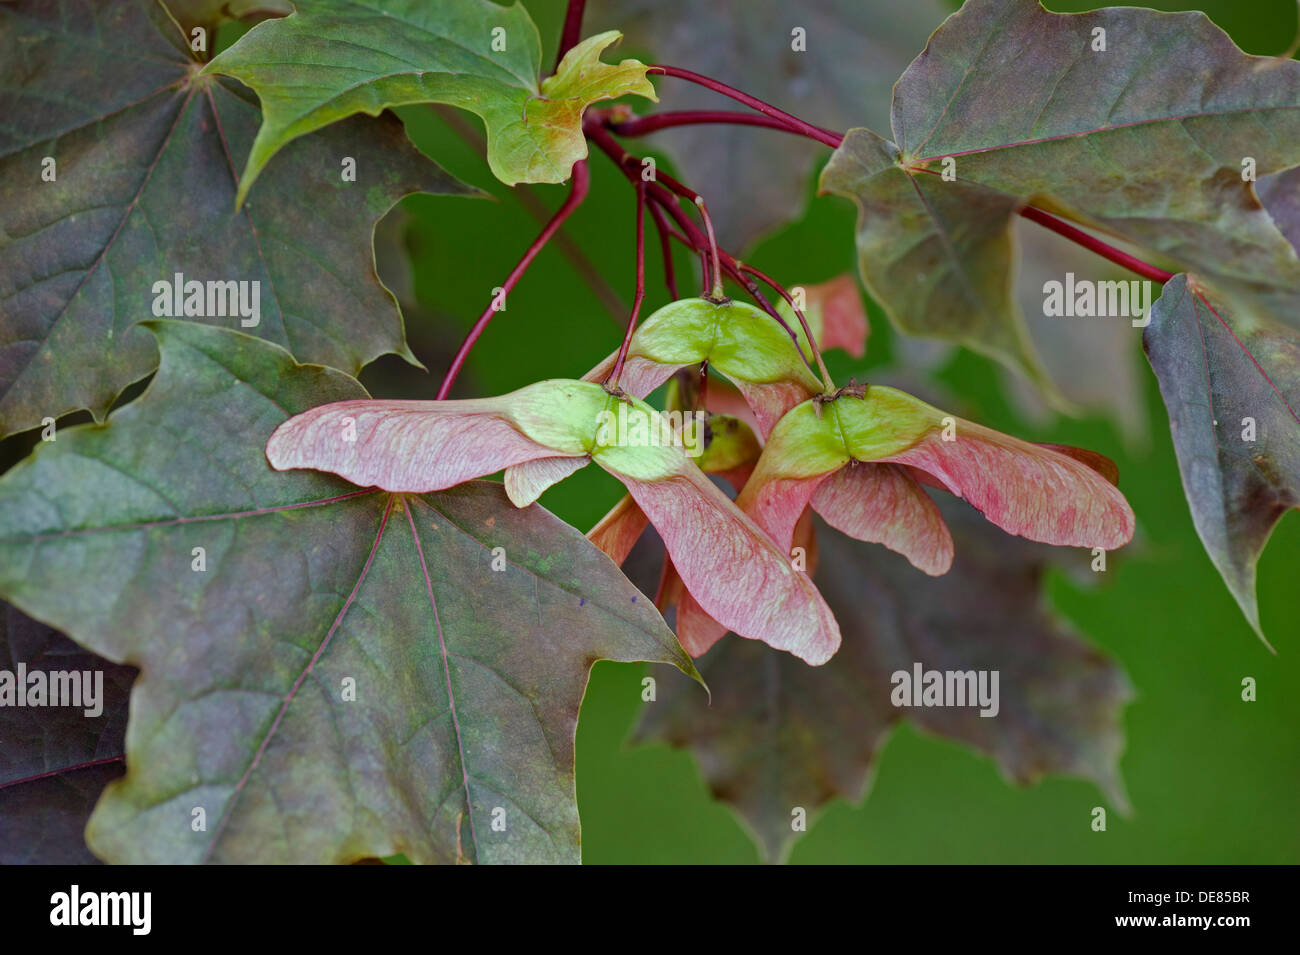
xmin=0 ymin=604 xmax=135 ymax=865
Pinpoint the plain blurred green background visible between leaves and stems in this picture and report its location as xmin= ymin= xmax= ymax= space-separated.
xmin=364 ymin=0 xmax=1300 ymax=863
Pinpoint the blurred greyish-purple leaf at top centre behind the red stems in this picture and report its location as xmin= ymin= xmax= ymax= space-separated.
xmin=590 ymin=0 xmax=948 ymax=252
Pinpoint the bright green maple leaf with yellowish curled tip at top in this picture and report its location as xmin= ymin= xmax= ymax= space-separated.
xmin=207 ymin=0 xmax=655 ymax=200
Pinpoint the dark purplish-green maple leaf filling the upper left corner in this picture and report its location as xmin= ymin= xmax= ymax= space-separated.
xmin=0 ymin=0 xmax=473 ymax=435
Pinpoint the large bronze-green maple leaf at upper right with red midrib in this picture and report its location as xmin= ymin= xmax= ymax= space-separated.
xmin=822 ymin=0 xmax=1300 ymax=385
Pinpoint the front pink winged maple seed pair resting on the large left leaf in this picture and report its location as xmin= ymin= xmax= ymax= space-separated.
xmin=267 ymin=379 xmax=840 ymax=665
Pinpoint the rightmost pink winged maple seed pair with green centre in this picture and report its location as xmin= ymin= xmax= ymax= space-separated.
xmin=736 ymin=385 xmax=1134 ymax=576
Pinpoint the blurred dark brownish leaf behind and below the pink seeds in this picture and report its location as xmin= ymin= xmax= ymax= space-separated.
xmin=636 ymin=509 xmax=1132 ymax=860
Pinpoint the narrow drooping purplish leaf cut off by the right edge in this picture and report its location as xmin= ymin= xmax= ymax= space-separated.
xmin=1143 ymin=275 xmax=1300 ymax=647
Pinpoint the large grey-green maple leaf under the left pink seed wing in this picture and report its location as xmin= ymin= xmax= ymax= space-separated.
xmin=0 ymin=322 xmax=697 ymax=863
